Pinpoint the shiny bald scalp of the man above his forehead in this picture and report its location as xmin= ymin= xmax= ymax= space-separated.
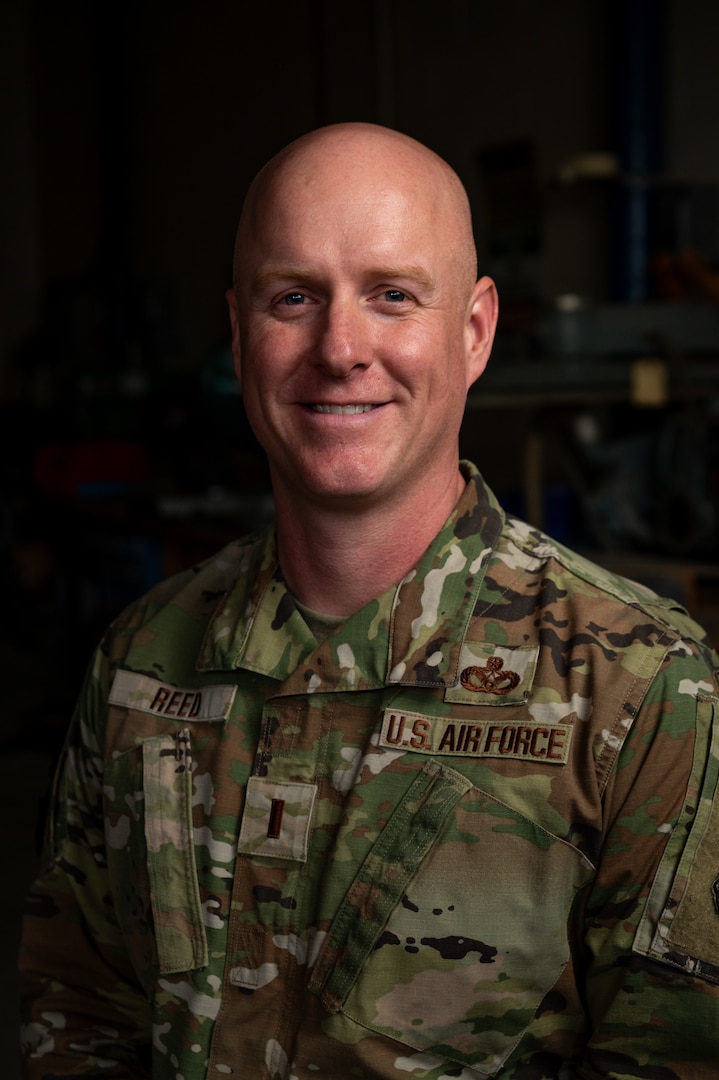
xmin=234 ymin=123 xmax=477 ymax=295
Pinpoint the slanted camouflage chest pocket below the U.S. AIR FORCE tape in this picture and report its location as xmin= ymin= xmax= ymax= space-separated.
xmin=310 ymin=760 xmax=594 ymax=1077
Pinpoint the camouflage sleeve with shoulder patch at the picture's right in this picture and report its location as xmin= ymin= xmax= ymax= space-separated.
xmin=578 ymin=643 xmax=719 ymax=1080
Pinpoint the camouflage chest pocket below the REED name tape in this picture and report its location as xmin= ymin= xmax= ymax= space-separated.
xmin=105 ymin=728 xmax=207 ymax=981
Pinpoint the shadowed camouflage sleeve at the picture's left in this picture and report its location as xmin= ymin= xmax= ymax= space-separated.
xmin=19 ymin=635 xmax=151 ymax=1080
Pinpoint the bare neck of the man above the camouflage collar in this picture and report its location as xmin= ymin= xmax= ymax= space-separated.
xmin=269 ymin=470 xmax=465 ymax=617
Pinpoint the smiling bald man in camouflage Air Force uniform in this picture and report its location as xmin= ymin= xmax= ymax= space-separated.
xmin=22 ymin=124 xmax=719 ymax=1080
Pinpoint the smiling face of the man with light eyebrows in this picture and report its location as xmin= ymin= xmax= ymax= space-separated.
xmin=230 ymin=138 xmax=493 ymax=507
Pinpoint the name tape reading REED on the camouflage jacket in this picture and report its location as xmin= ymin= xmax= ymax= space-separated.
xmin=108 ymin=671 xmax=238 ymax=721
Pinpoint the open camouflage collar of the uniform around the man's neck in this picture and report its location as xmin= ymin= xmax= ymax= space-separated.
xmin=198 ymin=462 xmax=504 ymax=693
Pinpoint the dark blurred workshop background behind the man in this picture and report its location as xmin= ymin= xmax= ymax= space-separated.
xmin=0 ymin=0 xmax=719 ymax=1080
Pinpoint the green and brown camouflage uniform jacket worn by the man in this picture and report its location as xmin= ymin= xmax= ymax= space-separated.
xmin=22 ymin=467 xmax=719 ymax=1080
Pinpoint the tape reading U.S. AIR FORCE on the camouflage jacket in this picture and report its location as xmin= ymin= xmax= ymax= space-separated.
xmin=379 ymin=708 xmax=572 ymax=765
